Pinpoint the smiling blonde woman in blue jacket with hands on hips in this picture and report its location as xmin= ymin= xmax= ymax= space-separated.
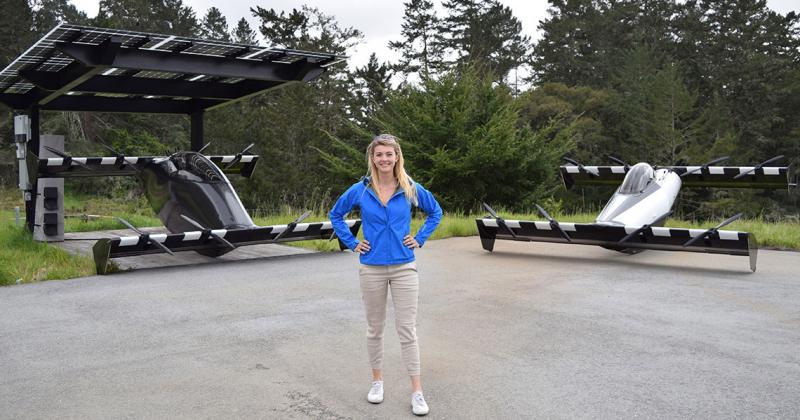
xmin=330 ymin=134 xmax=442 ymax=416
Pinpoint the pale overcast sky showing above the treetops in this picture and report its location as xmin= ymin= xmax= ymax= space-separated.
xmin=71 ymin=0 xmax=800 ymax=68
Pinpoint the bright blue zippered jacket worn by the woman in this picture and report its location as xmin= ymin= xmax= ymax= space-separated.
xmin=328 ymin=177 xmax=442 ymax=265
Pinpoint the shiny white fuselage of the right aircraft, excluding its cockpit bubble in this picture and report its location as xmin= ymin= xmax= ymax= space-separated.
xmin=596 ymin=169 xmax=681 ymax=226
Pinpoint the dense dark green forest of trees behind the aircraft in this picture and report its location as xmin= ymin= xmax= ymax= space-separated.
xmin=0 ymin=0 xmax=800 ymax=220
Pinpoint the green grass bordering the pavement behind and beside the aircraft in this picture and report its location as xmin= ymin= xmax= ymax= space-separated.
xmin=0 ymin=190 xmax=800 ymax=285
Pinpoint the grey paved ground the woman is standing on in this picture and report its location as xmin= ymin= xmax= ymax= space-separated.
xmin=0 ymin=238 xmax=800 ymax=419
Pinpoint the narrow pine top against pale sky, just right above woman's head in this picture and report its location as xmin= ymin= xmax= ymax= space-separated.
xmin=389 ymin=0 xmax=442 ymax=79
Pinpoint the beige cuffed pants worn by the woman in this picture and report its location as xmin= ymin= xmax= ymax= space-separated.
xmin=358 ymin=262 xmax=420 ymax=376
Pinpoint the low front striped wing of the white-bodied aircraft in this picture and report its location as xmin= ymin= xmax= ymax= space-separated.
xmin=476 ymin=218 xmax=758 ymax=271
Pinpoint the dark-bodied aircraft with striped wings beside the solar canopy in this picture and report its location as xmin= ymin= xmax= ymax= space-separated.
xmin=39 ymin=144 xmax=361 ymax=274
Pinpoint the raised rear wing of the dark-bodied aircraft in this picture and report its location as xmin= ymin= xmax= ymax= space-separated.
xmin=39 ymin=155 xmax=259 ymax=178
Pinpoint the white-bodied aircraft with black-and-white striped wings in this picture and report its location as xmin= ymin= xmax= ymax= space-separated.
xmin=476 ymin=156 xmax=795 ymax=271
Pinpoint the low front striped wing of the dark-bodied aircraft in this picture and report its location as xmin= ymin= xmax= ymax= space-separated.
xmin=93 ymin=220 xmax=361 ymax=274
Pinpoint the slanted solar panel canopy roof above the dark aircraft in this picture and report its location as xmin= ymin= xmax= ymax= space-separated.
xmin=0 ymin=24 xmax=345 ymax=114
